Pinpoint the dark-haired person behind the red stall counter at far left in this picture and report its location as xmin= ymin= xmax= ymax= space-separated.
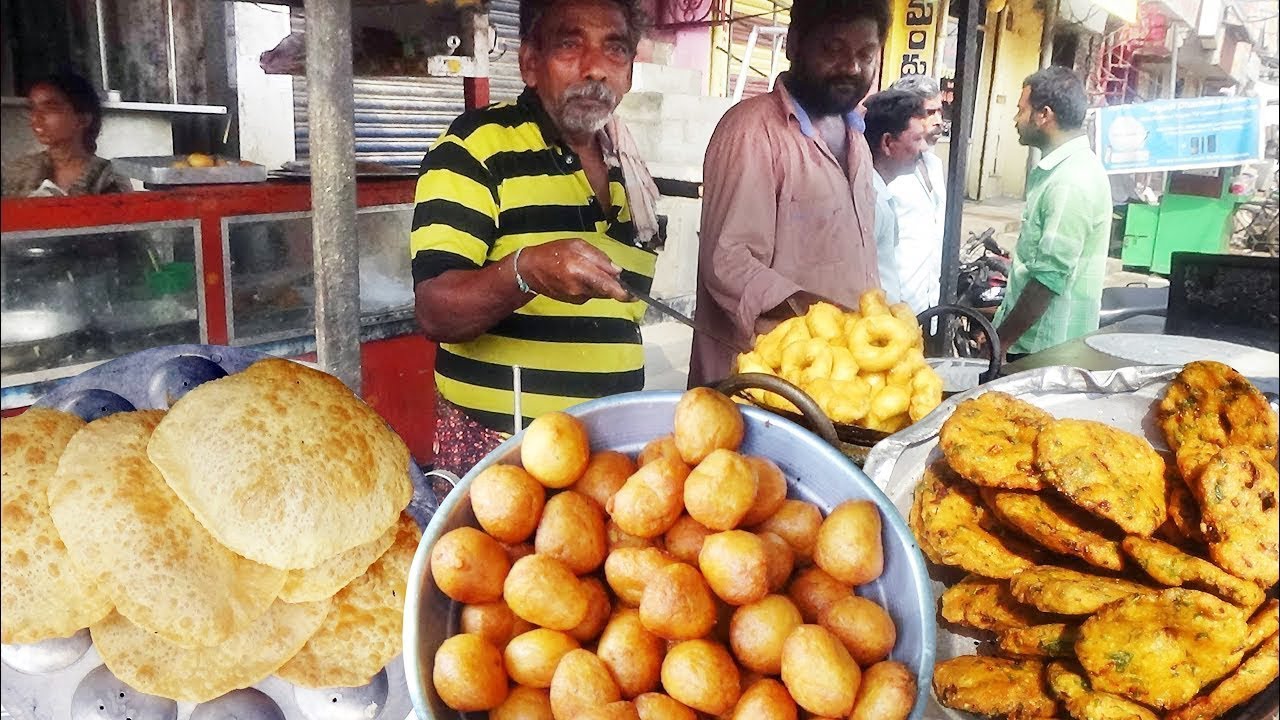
xmin=4 ymin=72 xmax=133 ymax=197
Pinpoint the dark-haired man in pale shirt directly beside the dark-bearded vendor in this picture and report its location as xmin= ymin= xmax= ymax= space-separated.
xmin=864 ymin=90 xmax=927 ymax=302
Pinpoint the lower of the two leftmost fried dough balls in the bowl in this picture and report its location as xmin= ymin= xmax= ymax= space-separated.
xmin=431 ymin=633 xmax=507 ymax=712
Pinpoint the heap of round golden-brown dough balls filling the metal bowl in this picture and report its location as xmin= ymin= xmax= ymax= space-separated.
xmin=430 ymin=388 xmax=915 ymax=720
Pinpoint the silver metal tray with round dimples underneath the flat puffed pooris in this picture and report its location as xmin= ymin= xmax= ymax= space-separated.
xmin=0 ymin=345 xmax=438 ymax=720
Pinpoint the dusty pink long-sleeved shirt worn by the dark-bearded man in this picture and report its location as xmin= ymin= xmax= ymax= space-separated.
xmin=689 ymin=82 xmax=879 ymax=387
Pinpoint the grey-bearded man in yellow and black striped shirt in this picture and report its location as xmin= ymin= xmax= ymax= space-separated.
xmin=410 ymin=0 xmax=655 ymax=474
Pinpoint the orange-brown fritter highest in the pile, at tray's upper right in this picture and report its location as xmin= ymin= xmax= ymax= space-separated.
xmin=1156 ymin=360 xmax=1277 ymax=479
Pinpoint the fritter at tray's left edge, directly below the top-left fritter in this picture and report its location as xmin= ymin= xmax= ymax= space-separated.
xmin=910 ymin=462 xmax=1036 ymax=578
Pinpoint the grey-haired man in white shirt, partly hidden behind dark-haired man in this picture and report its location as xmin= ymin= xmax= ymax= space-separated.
xmin=888 ymin=76 xmax=947 ymax=314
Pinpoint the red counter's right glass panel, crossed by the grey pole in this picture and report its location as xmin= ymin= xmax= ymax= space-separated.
xmin=223 ymin=204 xmax=413 ymax=345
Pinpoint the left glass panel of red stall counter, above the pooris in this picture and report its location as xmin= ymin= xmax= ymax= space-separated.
xmin=0 ymin=220 xmax=206 ymax=387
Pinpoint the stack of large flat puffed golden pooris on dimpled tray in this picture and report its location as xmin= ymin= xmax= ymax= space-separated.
xmin=3 ymin=359 xmax=421 ymax=702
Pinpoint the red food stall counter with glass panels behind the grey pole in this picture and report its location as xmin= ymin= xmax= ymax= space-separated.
xmin=0 ymin=178 xmax=435 ymax=462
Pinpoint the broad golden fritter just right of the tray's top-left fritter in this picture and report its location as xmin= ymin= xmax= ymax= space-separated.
xmin=1036 ymin=420 xmax=1167 ymax=537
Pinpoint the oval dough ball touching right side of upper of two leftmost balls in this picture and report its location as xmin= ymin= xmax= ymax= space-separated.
xmin=502 ymin=553 xmax=588 ymax=630
